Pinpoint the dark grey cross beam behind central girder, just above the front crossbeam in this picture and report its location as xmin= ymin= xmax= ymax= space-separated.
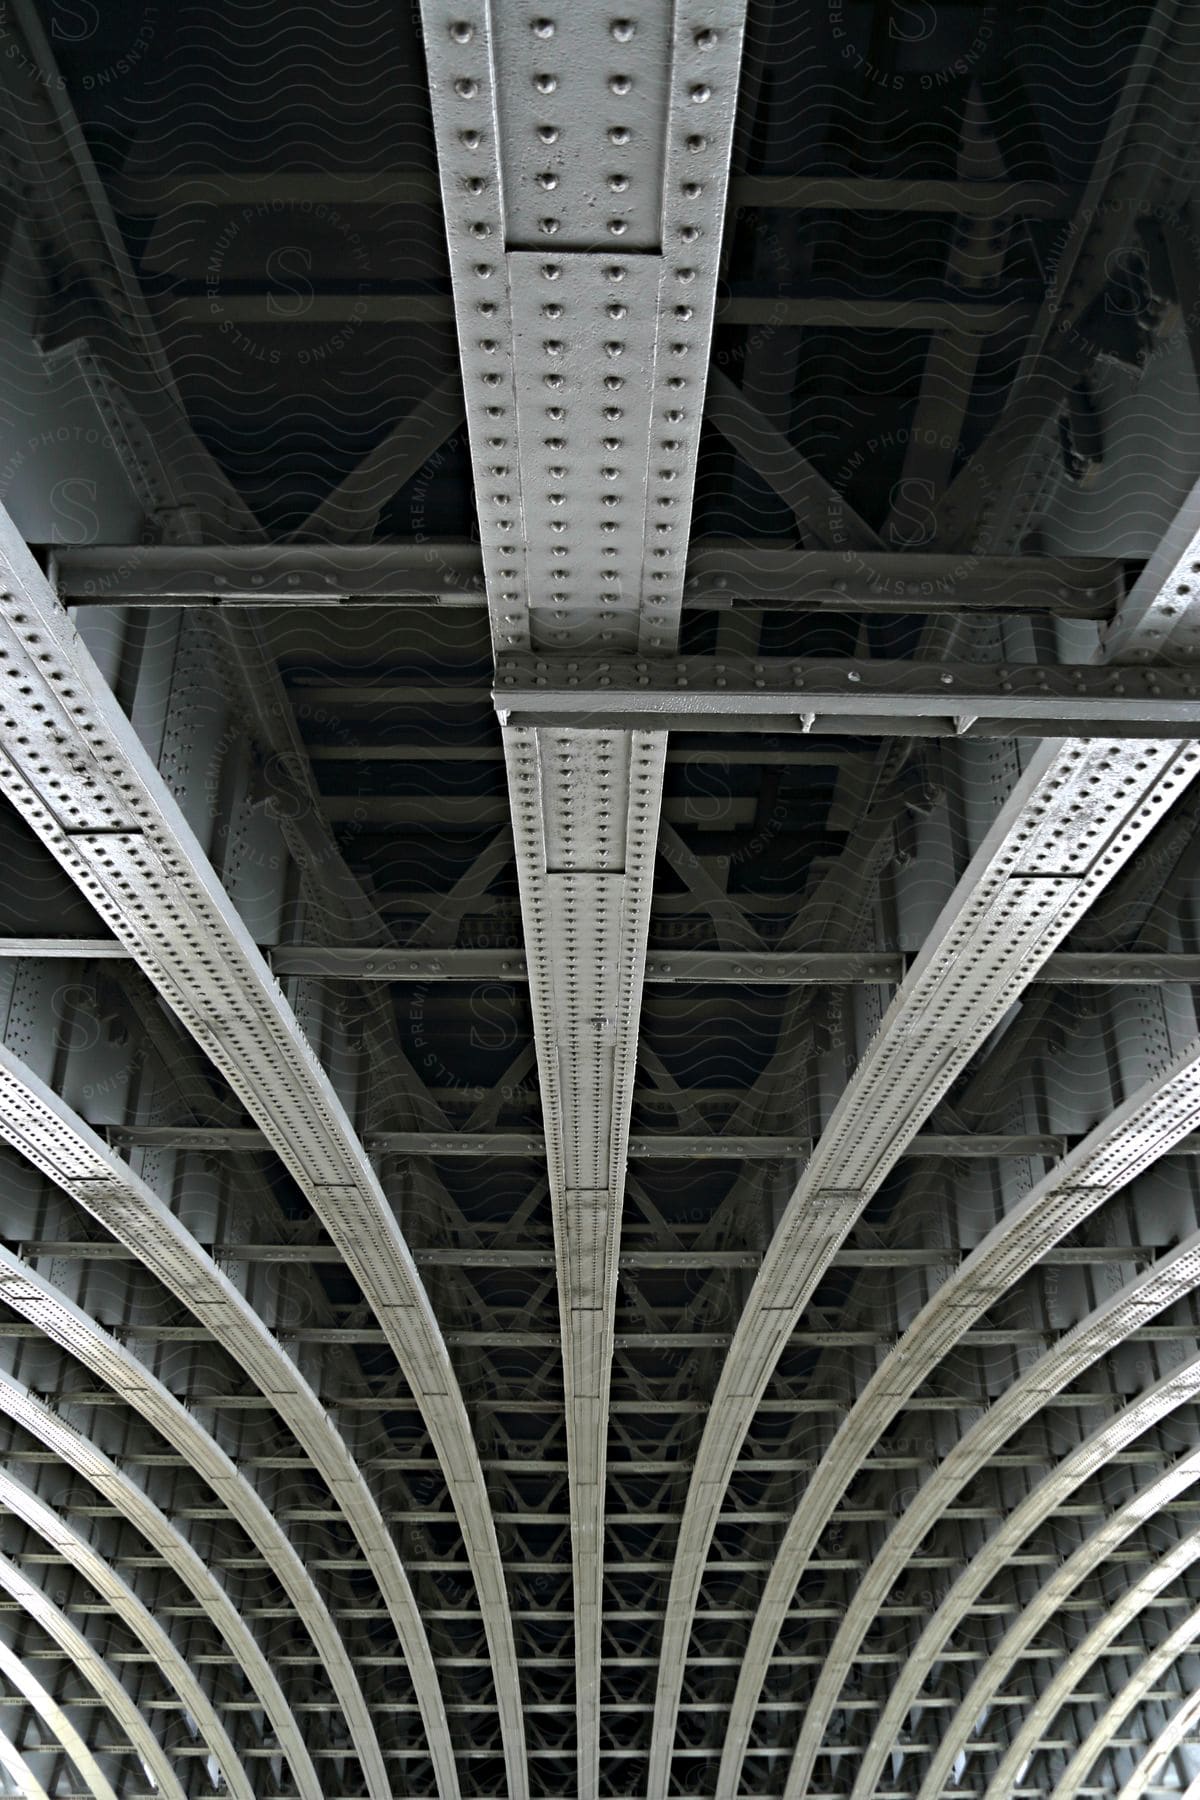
xmin=43 ymin=538 xmax=1126 ymax=619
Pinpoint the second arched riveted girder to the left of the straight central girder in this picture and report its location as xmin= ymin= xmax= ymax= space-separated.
xmin=0 ymin=1046 xmax=457 ymax=1784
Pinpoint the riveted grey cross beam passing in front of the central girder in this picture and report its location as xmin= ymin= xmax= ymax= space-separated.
xmin=495 ymin=655 xmax=1200 ymax=738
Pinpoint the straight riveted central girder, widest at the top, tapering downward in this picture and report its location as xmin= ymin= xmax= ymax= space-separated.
xmin=423 ymin=10 xmax=745 ymax=1800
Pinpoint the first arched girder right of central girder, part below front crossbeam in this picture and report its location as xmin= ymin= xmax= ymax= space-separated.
xmin=649 ymin=740 xmax=1196 ymax=1795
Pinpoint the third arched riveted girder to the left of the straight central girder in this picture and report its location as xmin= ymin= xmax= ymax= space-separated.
xmin=0 ymin=1246 xmax=390 ymax=1800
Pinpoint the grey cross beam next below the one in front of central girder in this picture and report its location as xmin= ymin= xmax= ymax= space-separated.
xmin=9 ymin=936 xmax=1200 ymax=986
